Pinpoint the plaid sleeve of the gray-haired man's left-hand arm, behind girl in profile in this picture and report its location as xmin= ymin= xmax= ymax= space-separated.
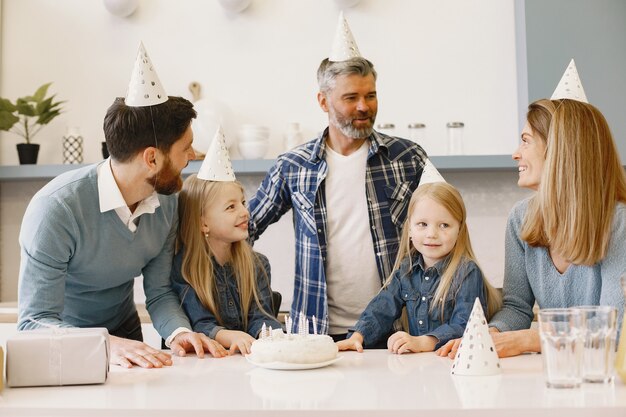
xmin=248 ymin=157 xmax=291 ymax=243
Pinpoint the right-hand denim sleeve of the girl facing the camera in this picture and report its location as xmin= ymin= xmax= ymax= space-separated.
xmin=426 ymin=262 xmax=487 ymax=349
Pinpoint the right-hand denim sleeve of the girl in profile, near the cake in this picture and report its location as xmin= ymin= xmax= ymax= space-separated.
xmin=247 ymin=253 xmax=282 ymax=338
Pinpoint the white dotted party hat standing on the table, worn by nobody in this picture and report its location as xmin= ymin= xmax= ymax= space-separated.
xmin=451 ymin=298 xmax=500 ymax=376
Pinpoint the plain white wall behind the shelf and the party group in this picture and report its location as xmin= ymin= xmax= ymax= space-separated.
xmin=0 ymin=0 xmax=519 ymax=164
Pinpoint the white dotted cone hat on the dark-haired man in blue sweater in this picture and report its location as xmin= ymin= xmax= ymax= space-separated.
xmin=125 ymin=42 xmax=168 ymax=107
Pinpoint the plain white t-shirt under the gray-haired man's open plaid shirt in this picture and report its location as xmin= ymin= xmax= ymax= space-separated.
xmin=325 ymin=140 xmax=381 ymax=334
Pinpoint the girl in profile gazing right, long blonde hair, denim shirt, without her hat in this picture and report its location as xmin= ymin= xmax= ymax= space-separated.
xmin=172 ymin=175 xmax=281 ymax=354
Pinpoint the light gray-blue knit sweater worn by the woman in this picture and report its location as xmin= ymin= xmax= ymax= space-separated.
xmin=489 ymin=199 xmax=626 ymax=331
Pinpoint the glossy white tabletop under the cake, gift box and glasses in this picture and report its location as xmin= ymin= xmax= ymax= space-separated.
xmin=0 ymin=322 xmax=626 ymax=417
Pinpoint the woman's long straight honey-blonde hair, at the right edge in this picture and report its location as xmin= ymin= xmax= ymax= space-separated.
xmin=521 ymin=99 xmax=626 ymax=265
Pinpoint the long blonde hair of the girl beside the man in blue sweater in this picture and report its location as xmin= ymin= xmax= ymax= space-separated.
xmin=176 ymin=174 xmax=269 ymax=329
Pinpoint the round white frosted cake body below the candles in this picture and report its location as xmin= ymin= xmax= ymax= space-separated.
xmin=252 ymin=332 xmax=338 ymax=363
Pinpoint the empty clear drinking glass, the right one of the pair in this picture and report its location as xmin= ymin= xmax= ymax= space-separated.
xmin=574 ymin=306 xmax=617 ymax=382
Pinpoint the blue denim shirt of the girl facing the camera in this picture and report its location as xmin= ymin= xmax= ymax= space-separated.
xmin=354 ymin=254 xmax=487 ymax=349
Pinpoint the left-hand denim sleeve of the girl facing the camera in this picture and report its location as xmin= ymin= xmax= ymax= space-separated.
xmin=348 ymin=271 xmax=404 ymax=347
